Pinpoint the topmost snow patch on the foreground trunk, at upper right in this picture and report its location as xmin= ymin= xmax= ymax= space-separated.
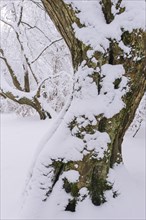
xmin=65 ymin=0 xmax=146 ymax=52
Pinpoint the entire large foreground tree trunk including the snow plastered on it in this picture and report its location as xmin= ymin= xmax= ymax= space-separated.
xmin=23 ymin=0 xmax=146 ymax=211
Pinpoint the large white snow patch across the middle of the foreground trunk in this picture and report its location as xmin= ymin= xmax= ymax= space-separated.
xmin=69 ymin=61 xmax=129 ymax=118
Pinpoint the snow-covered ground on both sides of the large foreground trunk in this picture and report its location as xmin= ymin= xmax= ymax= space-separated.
xmin=1 ymin=114 xmax=146 ymax=220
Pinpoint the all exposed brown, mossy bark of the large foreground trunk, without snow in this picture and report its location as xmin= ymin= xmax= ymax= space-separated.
xmin=42 ymin=0 xmax=146 ymax=211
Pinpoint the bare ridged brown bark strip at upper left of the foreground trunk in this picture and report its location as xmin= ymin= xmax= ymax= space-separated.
xmin=42 ymin=0 xmax=86 ymax=70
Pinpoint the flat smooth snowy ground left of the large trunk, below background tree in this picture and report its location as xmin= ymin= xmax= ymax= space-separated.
xmin=0 ymin=114 xmax=49 ymax=219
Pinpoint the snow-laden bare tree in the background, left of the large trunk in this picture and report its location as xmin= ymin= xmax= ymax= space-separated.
xmin=0 ymin=0 xmax=71 ymax=119
